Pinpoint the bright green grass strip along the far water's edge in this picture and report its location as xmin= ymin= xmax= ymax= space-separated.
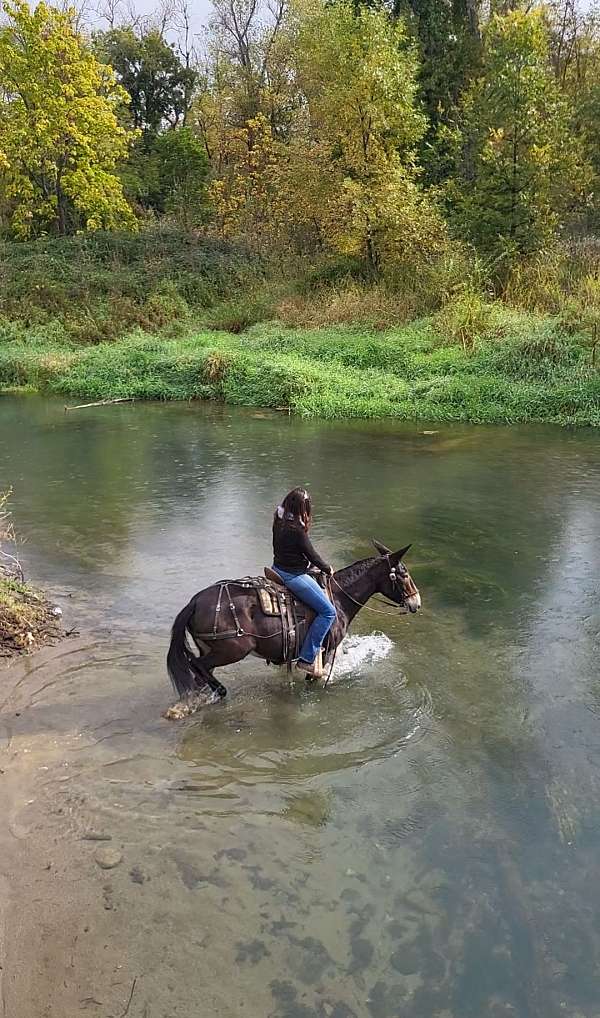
xmin=0 ymin=313 xmax=600 ymax=426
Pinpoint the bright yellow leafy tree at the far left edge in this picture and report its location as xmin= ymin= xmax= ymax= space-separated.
xmin=0 ymin=0 xmax=134 ymax=237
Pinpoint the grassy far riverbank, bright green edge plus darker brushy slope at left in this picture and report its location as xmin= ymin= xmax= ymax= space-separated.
xmin=0 ymin=230 xmax=600 ymax=426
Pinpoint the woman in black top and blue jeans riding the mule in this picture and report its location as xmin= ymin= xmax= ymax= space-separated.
xmin=273 ymin=488 xmax=335 ymax=676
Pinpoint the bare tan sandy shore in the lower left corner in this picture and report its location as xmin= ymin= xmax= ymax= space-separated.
xmin=0 ymin=637 xmax=171 ymax=1018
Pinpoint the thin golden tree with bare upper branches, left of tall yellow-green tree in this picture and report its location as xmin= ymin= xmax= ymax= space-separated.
xmin=192 ymin=0 xmax=298 ymax=248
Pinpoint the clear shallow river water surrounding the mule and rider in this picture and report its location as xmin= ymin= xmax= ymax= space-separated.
xmin=0 ymin=397 xmax=600 ymax=1018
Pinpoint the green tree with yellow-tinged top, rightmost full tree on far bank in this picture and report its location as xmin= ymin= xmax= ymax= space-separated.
xmin=450 ymin=10 xmax=589 ymax=259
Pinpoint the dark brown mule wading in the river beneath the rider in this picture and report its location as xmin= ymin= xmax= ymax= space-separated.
xmin=167 ymin=541 xmax=421 ymax=697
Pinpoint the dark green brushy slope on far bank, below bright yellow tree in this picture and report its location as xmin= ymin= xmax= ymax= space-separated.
xmin=0 ymin=227 xmax=264 ymax=343
